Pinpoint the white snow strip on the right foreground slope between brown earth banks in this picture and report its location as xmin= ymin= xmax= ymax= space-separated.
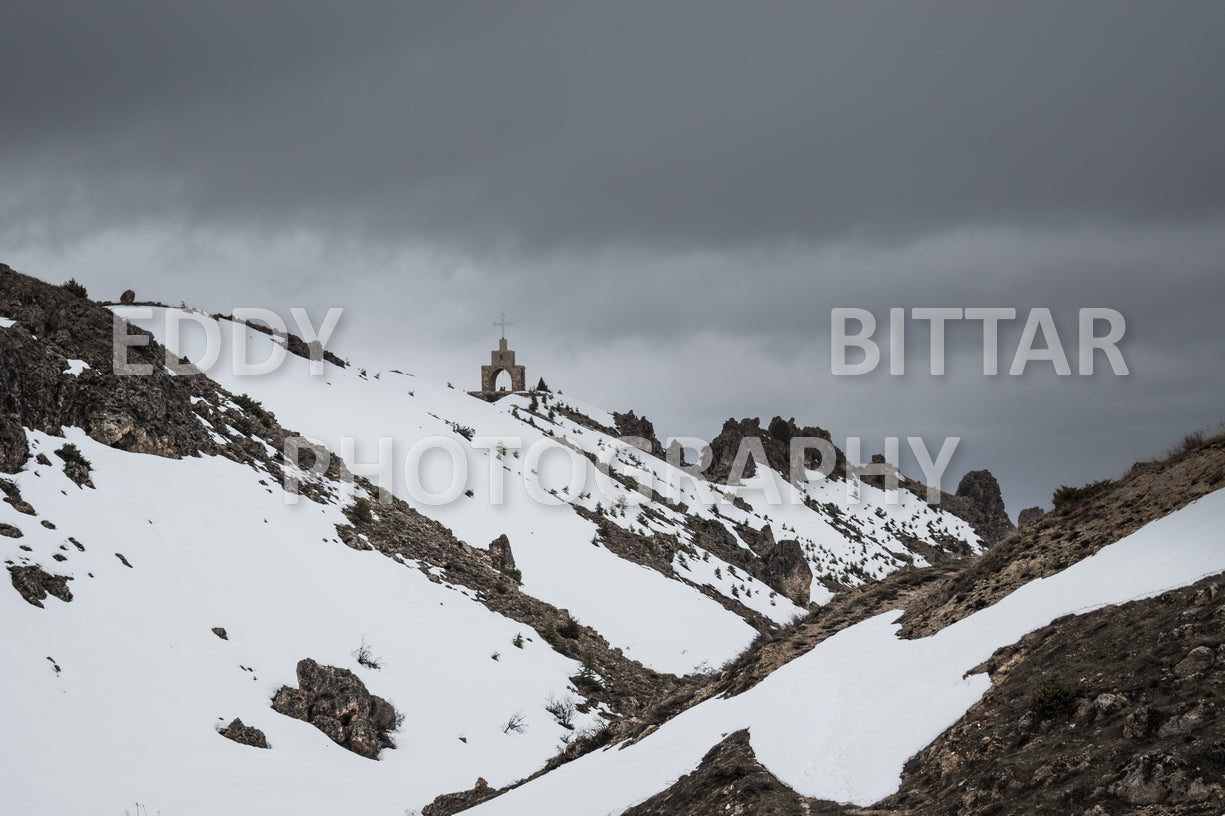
xmin=467 ymin=482 xmax=1225 ymax=816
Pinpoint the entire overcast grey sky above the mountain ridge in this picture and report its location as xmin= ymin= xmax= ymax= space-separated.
xmin=0 ymin=0 xmax=1225 ymax=515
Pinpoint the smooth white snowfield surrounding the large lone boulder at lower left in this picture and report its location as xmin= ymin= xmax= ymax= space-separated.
xmin=0 ymin=429 xmax=610 ymax=816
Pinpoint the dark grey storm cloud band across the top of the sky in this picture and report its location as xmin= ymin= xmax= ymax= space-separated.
xmin=7 ymin=2 xmax=1225 ymax=247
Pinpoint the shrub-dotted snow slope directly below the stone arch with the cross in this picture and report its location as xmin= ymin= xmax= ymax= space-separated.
xmin=115 ymin=308 xmax=980 ymax=674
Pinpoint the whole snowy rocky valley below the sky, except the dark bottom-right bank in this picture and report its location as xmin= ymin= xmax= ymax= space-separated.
xmin=0 ymin=267 xmax=1225 ymax=816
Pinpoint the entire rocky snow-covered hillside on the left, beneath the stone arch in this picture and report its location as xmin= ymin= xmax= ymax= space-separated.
xmin=0 ymin=265 xmax=1033 ymax=816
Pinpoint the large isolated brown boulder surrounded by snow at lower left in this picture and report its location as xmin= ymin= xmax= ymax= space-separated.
xmin=272 ymin=658 xmax=396 ymax=760
